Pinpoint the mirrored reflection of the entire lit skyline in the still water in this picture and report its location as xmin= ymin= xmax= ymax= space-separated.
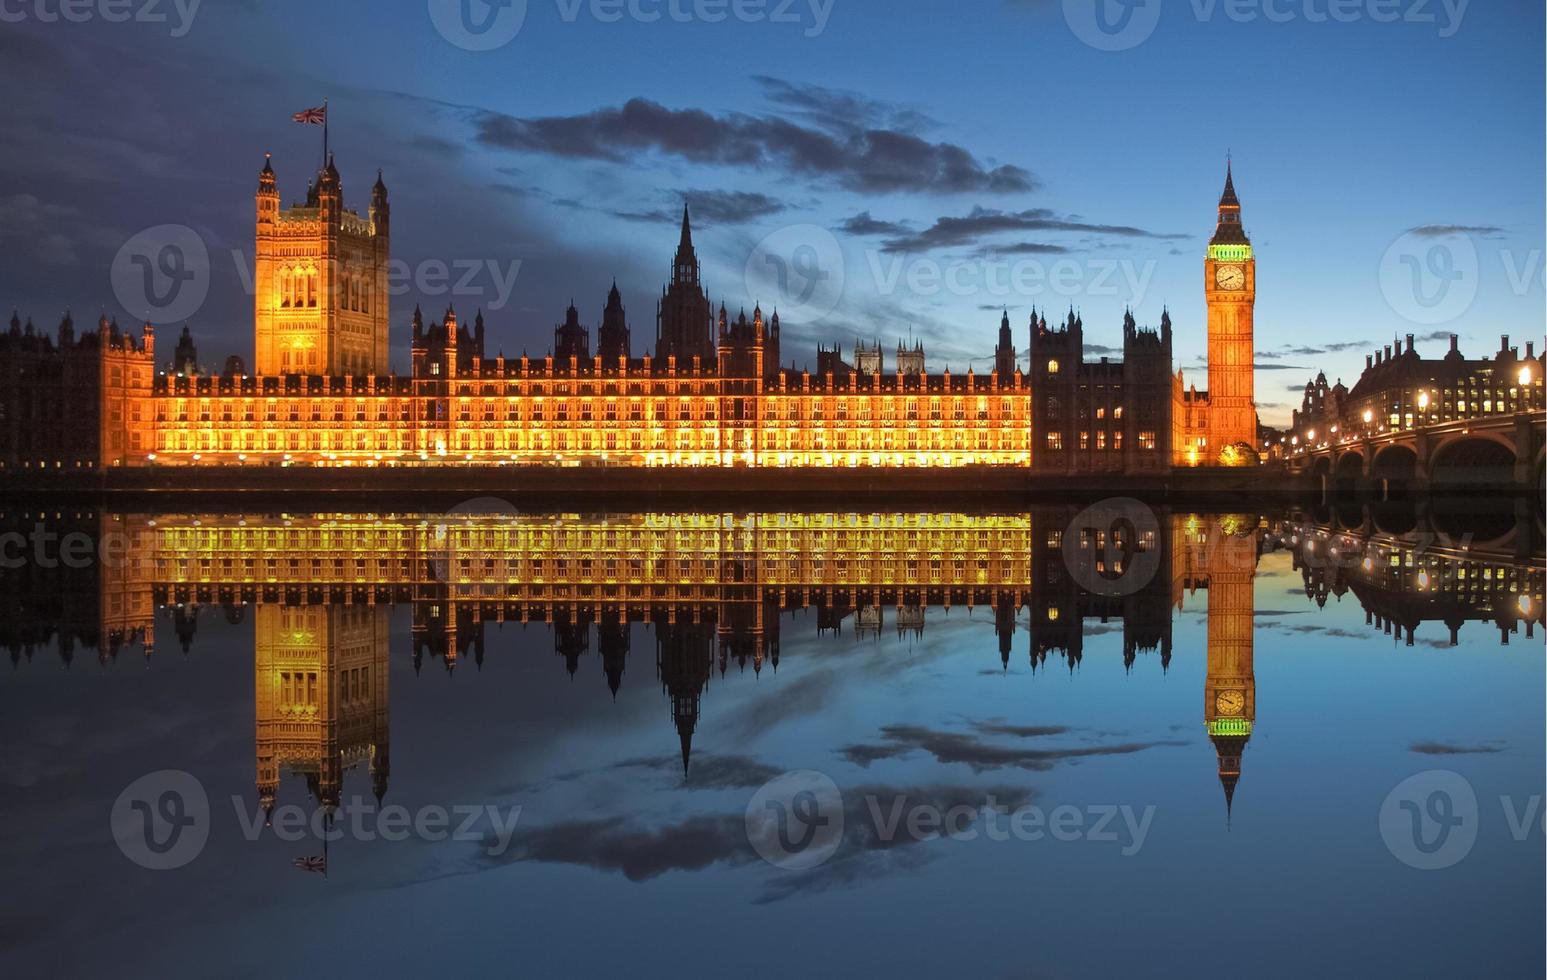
xmin=0 ymin=505 xmax=1544 ymax=814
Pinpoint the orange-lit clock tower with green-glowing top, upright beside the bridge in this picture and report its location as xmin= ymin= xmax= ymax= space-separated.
xmin=1204 ymin=164 xmax=1256 ymax=463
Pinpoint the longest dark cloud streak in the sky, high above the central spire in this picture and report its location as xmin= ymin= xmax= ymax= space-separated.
xmin=473 ymin=98 xmax=1035 ymax=194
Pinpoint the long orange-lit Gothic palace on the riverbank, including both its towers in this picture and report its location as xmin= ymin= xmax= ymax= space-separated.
xmin=0 ymin=151 xmax=1258 ymax=475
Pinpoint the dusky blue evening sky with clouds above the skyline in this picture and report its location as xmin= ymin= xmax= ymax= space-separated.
xmin=0 ymin=0 xmax=1544 ymax=423
